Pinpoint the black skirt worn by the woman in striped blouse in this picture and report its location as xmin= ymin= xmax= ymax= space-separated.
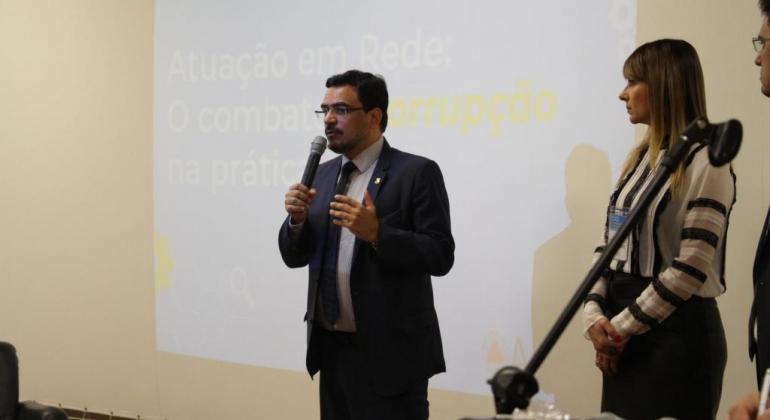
xmin=602 ymin=272 xmax=727 ymax=420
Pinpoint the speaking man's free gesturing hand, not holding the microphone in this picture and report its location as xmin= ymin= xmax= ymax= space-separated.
xmin=329 ymin=191 xmax=380 ymax=243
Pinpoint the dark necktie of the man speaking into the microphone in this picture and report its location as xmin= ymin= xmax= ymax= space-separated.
xmin=321 ymin=161 xmax=356 ymax=325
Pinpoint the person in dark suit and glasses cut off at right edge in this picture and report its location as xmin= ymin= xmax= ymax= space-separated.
xmin=730 ymin=0 xmax=770 ymax=420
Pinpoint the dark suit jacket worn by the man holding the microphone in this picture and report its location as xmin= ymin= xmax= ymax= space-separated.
xmin=278 ymin=141 xmax=454 ymax=395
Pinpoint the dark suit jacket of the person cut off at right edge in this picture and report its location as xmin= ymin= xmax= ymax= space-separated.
xmin=749 ymin=209 xmax=770 ymax=387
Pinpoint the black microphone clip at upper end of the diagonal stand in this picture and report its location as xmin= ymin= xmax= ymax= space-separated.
xmin=680 ymin=118 xmax=743 ymax=167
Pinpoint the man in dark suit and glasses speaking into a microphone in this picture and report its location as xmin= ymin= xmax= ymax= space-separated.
xmin=279 ymin=70 xmax=454 ymax=420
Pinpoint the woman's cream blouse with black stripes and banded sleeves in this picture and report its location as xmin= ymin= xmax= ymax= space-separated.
xmin=583 ymin=144 xmax=735 ymax=336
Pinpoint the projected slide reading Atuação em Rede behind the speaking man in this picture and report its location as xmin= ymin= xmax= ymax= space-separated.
xmin=154 ymin=0 xmax=636 ymax=394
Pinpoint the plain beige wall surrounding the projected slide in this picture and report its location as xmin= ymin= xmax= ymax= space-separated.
xmin=0 ymin=0 xmax=770 ymax=420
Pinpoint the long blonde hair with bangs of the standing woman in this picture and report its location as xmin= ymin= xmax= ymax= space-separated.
xmin=620 ymin=39 xmax=707 ymax=196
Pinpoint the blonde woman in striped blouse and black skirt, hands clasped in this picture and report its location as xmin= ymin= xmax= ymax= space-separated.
xmin=583 ymin=39 xmax=735 ymax=420
